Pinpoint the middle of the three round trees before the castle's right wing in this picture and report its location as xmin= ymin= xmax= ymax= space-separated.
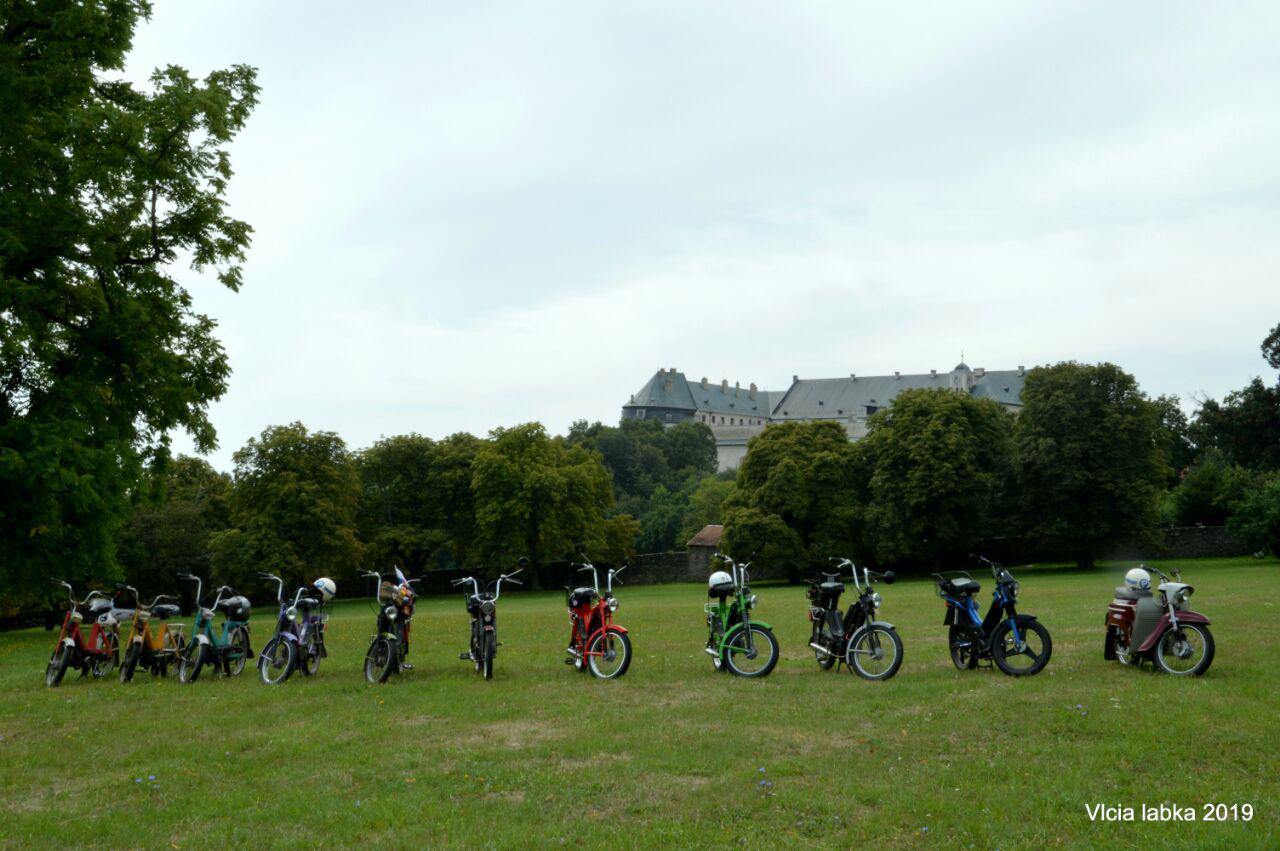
xmin=856 ymin=390 xmax=1012 ymax=564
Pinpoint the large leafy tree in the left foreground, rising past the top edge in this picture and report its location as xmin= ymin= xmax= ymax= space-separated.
xmin=0 ymin=0 xmax=259 ymax=606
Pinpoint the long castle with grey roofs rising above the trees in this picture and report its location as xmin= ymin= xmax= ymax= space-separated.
xmin=622 ymin=362 xmax=1027 ymax=470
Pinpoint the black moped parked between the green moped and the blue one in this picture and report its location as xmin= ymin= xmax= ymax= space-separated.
xmin=808 ymin=558 xmax=902 ymax=680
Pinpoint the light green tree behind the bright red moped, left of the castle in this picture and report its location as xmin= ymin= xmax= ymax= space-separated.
xmin=471 ymin=422 xmax=639 ymax=569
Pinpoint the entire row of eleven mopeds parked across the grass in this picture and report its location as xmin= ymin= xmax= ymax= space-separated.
xmin=45 ymin=548 xmax=1215 ymax=686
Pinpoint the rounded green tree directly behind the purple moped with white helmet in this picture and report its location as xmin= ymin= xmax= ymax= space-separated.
xmin=214 ymin=422 xmax=364 ymax=587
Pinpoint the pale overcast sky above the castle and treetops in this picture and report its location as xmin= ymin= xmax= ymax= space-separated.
xmin=129 ymin=0 xmax=1280 ymax=468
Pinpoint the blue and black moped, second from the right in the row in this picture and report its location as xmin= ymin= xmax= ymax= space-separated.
xmin=933 ymin=557 xmax=1053 ymax=677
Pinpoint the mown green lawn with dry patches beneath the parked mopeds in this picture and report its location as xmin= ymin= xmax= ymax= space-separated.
xmin=0 ymin=559 xmax=1280 ymax=848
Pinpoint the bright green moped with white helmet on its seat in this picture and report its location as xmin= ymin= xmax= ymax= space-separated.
xmin=703 ymin=553 xmax=778 ymax=677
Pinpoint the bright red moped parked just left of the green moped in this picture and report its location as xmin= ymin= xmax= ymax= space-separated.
xmin=564 ymin=548 xmax=631 ymax=680
